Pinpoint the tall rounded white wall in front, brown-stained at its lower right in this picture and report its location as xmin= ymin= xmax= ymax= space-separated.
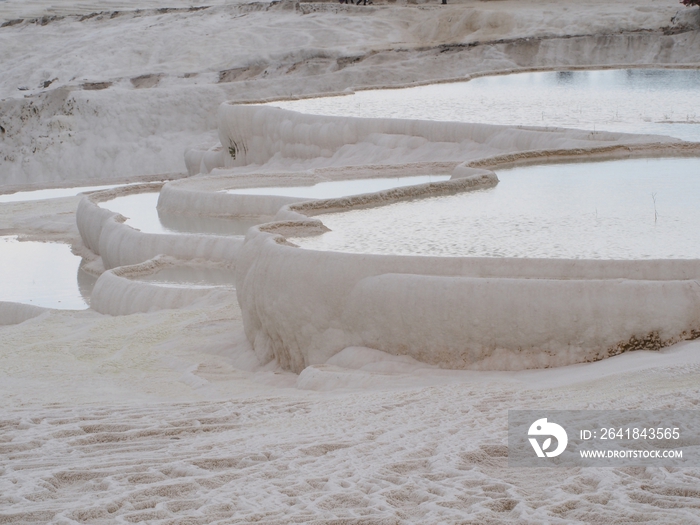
xmin=236 ymin=200 xmax=700 ymax=372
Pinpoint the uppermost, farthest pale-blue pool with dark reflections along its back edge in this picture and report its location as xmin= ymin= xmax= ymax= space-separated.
xmin=270 ymin=69 xmax=700 ymax=141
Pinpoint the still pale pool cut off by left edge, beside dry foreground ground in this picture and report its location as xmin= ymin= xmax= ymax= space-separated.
xmin=0 ymin=236 xmax=89 ymax=310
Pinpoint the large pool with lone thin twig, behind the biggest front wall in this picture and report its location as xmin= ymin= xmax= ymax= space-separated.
xmin=290 ymin=158 xmax=700 ymax=259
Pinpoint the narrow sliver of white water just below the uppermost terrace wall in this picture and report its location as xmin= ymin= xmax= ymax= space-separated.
xmin=225 ymin=175 xmax=450 ymax=199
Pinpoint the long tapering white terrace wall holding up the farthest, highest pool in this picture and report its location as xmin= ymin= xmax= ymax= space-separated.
xmin=196 ymin=104 xmax=674 ymax=171
